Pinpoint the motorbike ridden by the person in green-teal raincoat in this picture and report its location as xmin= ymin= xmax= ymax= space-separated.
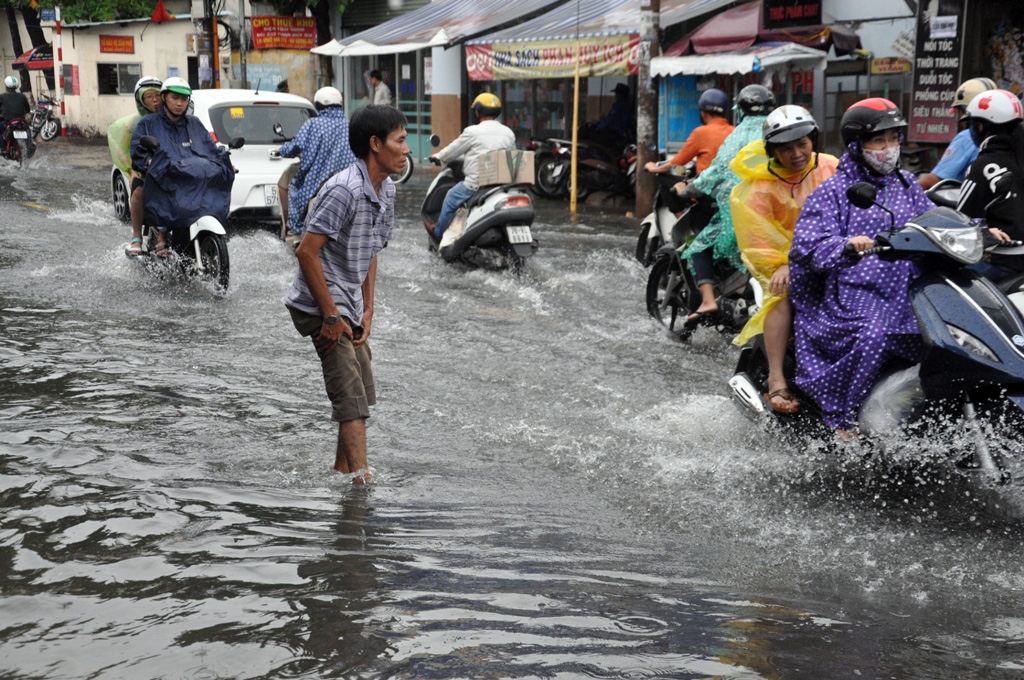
xmin=638 ymin=179 xmax=763 ymax=340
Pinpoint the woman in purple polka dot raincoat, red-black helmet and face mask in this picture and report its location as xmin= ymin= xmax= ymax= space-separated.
xmin=790 ymin=97 xmax=934 ymax=435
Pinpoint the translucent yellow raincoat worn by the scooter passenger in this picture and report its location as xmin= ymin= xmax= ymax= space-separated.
xmin=729 ymin=139 xmax=839 ymax=345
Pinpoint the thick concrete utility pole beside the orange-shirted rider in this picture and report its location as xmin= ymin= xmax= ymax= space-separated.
xmin=636 ymin=0 xmax=662 ymax=218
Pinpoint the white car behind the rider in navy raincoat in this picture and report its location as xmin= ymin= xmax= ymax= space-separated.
xmin=111 ymin=90 xmax=316 ymax=222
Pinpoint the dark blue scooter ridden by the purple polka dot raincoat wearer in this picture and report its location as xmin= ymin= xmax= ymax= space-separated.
xmin=728 ymin=182 xmax=1024 ymax=484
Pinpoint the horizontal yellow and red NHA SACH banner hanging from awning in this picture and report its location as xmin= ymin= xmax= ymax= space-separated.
xmin=466 ymin=35 xmax=640 ymax=80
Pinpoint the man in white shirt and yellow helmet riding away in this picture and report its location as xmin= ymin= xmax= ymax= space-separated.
xmin=427 ymin=92 xmax=515 ymax=241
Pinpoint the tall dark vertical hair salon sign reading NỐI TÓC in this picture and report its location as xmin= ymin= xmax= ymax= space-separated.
xmin=909 ymin=3 xmax=964 ymax=142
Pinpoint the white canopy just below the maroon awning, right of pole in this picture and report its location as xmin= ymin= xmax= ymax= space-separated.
xmin=650 ymin=43 xmax=826 ymax=76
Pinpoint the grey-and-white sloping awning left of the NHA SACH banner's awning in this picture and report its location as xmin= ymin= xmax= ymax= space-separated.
xmin=311 ymin=0 xmax=559 ymax=56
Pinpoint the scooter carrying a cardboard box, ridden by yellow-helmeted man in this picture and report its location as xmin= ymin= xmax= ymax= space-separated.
xmin=421 ymin=134 xmax=539 ymax=272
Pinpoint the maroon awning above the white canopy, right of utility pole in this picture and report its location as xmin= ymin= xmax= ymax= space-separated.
xmin=664 ymin=0 xmax=860 ymax=56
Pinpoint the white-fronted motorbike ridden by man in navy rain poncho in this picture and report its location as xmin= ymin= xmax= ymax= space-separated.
xmin=125 ymin=135 xmax=239 ymax=295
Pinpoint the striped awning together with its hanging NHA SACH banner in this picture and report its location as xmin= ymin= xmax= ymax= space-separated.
xmin=466 ymin=0 xmax=731 ymax=80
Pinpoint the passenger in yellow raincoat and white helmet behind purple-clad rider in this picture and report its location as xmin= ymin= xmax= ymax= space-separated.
xmin=729 ymin=104 xmax=839 ymax=413
